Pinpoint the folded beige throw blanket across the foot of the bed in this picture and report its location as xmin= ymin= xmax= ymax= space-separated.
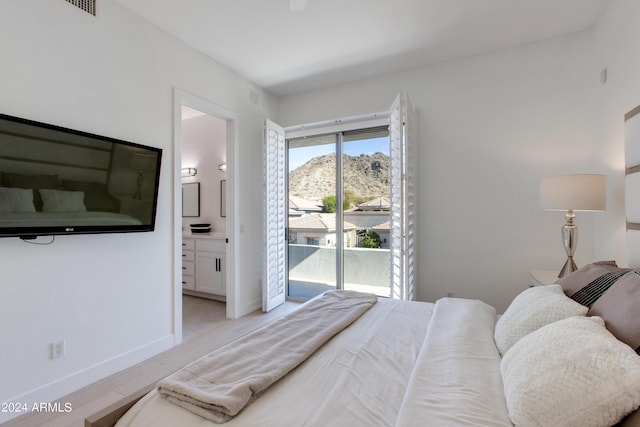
xmin=158 ymin=291 xmax=377 ymax=423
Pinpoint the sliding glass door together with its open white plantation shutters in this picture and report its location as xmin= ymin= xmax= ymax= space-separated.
xmin=262 ymin=94 xmax=417 ymax=311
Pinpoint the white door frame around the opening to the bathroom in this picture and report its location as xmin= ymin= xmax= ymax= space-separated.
xmin=173 ymin=88 xmax=240 ymax=345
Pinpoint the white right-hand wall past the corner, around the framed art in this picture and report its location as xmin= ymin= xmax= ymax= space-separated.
xmin=594 ymin=0 xmax=640 ymax=267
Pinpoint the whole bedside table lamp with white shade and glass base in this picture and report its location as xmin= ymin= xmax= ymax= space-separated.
xmin=540 ymin=174 xmax=607 ymax=277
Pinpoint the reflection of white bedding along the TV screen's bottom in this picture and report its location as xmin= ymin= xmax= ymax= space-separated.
xmin=0 ymin=211 xmax=141 ymax=227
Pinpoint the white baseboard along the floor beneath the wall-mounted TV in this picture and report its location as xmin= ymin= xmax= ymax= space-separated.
xmin=0 ymin=335 xmax=174 ymax=424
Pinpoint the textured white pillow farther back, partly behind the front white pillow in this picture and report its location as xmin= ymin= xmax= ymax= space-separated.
xmin=494 ymin=285 xmax=589 ymax=355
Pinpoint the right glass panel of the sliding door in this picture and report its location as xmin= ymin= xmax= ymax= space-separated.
xmin=342 ymin=128 xmax=391 ymax=297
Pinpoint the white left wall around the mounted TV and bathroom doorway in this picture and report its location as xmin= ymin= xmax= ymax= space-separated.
xmin=0 ymin=0 xmax=276 ymax=422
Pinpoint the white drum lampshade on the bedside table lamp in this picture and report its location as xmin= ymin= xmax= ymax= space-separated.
xmin=540 ymin=174 xmax=607 ymax=211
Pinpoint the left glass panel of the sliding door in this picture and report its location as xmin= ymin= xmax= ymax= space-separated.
xmin=287 ymin=134 xmax=338 ymax=299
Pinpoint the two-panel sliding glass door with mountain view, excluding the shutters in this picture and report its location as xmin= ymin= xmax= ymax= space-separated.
xmin=287 ymin=126 xmax=391 ymax=299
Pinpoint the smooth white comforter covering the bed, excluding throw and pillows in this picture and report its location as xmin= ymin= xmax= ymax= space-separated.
xmin=117 ymin=298 xmax=511 ymax=427
